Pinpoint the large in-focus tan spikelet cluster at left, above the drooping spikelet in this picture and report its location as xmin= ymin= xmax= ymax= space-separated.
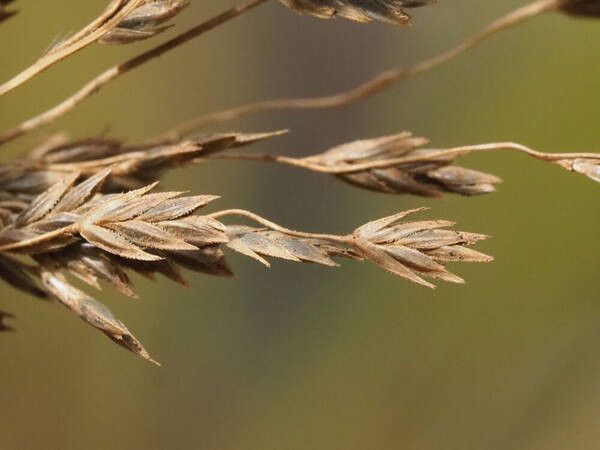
xmin=0 ymin=176 xmax=225 ymax=261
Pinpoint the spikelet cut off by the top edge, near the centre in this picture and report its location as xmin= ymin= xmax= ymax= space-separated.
xmin=280 ymin=0 xmax=435 ymax=25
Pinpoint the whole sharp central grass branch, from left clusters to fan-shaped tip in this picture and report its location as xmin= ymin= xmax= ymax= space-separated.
xmin=0 ymin=172 xmax=492 ymax=362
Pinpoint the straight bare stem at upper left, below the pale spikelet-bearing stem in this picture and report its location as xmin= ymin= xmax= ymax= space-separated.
xmin=0 ymin=0 xmax=267 ymax=145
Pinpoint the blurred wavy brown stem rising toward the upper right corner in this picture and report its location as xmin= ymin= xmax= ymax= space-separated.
xmin=158 ymin=0 xmax=564 ymax=141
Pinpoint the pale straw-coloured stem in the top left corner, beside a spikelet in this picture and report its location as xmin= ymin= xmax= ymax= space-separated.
xmin=0 ymin=0 xmax=144 ymax=96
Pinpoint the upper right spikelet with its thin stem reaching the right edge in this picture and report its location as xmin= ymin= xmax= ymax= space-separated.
xmin=209 ymin=132 xmax=600 ymax=197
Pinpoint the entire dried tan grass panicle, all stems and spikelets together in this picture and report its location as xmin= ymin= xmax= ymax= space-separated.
xmin=0 ymin=0 xmax=600 ymax=363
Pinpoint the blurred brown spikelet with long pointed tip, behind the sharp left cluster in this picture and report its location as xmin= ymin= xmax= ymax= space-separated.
xmin=0 ymin=131 xmax=284 ymax=196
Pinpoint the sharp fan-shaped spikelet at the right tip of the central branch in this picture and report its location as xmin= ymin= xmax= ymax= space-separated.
xmin=353 ymin=208 xmax=493 ymax=288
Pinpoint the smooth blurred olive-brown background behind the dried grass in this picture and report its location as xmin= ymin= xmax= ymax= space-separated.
xmin=0 ymin=0 xmax=600 ymax=450
